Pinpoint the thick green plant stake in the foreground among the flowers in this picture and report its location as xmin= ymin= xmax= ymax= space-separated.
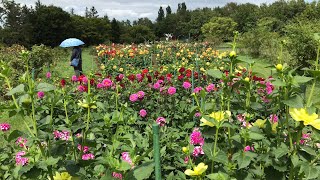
xmin=152 ymin=124 xmax=161 ymax=180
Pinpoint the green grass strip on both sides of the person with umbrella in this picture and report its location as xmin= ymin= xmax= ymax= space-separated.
xmin=52 ymin=49 xmax=98 ymax=78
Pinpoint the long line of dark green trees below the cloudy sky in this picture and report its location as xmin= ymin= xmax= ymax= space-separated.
xmin=0 ymin=0 xmax=320 ymax=47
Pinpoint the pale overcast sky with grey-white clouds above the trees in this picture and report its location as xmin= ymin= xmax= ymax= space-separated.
xmin=11 ymin=0 xmax=292 ymax=21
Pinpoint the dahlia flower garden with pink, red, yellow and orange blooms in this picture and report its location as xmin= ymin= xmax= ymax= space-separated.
xmin=0 ymin=38 xmax=320 ymax=180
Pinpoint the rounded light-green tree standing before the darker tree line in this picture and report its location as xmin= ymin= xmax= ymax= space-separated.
xmin=201 ymin=17 xmax=237 ymax=41
